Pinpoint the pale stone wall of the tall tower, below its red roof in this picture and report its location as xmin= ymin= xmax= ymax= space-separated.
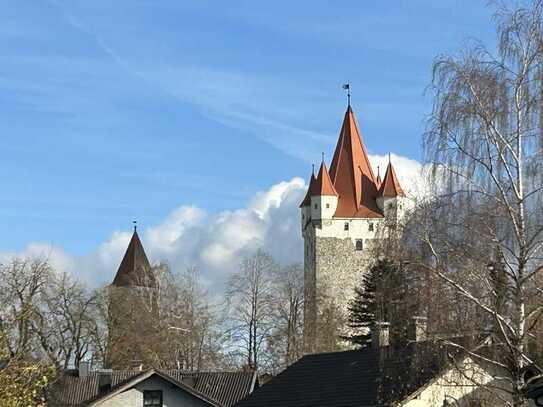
xmin=304 ymin=219 xmax=384 ymax=353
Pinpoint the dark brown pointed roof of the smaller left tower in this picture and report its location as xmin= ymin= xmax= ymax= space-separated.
xmin=111 ymin=227 xmax=156 ymax=288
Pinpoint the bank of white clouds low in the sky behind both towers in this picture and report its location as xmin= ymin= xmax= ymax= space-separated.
xmin=0 ymin=154 xmax=432 ymax=289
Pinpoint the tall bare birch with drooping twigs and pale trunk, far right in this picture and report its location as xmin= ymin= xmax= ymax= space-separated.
xmin=417 ymin=0 xmax=543 ymax=406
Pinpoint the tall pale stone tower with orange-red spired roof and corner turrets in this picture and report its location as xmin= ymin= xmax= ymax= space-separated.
xmin=300 ymin=105 xmax=405 ymax=353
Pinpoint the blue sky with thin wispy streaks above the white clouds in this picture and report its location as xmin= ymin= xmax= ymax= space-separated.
xmin=0 ymin=0 xmax=494 ymax=262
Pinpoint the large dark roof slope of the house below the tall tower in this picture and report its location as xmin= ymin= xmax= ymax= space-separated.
xmin=236 ymin=342 xmax=452 ymax=407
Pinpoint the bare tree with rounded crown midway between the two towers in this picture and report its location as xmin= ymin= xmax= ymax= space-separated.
xmin=227 ymin=250 xmax=277 ymax=370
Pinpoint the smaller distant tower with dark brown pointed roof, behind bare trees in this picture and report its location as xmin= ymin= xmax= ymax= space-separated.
xmin=105 ymin=227 xmax=160 ymax=369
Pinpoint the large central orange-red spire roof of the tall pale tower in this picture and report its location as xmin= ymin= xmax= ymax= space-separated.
xmin=330 ymin=106 xmax=383 ymax=218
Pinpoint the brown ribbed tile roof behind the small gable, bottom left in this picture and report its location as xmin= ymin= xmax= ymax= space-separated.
xmin=53 ymin=370 xmax=256 ymax=407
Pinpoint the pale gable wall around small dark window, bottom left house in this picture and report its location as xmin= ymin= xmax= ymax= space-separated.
xmin=97 ymin=376 xmax=209 ymax=407
